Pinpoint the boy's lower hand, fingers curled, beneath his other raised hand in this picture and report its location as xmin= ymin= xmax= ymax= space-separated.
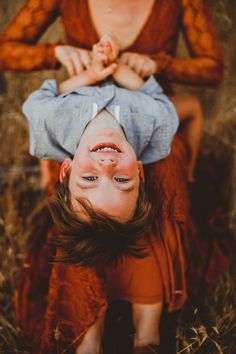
xmin=87 ymin=48 xmax=117 ymax=83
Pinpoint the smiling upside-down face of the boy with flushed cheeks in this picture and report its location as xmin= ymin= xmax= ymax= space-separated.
xmin=62 ymin=112 xmax=142 ymax=222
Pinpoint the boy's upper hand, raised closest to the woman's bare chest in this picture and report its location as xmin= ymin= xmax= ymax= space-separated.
xmin=98 ymin=33 xmax=121 ymax=63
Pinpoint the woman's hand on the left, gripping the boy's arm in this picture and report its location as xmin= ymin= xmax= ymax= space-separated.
xmin=55 ymin=45 xmax=91 ymax=77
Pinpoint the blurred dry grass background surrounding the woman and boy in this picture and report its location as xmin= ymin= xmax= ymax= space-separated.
xmin=0 ymin=0 xmax=236 ymax=354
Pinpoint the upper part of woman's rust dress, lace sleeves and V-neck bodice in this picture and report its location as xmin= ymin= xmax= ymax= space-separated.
xmin=0 ymin=0 xmax=223 ymax=84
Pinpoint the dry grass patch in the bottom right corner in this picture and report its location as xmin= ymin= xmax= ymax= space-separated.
xmin=176 ymin=270 xmax=236 ymax=354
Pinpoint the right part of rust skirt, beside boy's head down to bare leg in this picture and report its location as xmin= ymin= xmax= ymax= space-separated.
xmin=105 ymin=137 xmax=189 ymax=311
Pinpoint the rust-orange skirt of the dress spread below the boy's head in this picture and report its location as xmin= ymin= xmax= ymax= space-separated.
xmin=16 ymin=137 xmax=191 ymax=354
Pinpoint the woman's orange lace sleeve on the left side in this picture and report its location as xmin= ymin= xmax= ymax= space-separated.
xmin=0 ymin=0 xmax=58 ymax=72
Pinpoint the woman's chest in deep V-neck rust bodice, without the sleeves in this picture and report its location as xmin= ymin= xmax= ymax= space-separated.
xmin=60 ymin=0 xmax=182 ymax=54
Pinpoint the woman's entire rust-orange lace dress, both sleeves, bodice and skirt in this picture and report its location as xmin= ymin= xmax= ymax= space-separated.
xmin=0 ymin=0 xmax=227 ymax=353
